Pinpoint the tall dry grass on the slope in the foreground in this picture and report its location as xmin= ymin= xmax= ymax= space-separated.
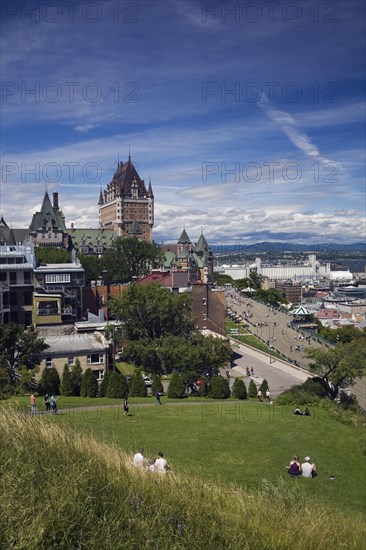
xmin=0 ymin=408 xmax=365 ymax=550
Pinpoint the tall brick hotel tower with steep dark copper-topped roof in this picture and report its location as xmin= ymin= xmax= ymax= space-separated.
xmin=98 ymin=156 xmax=154 ymax=242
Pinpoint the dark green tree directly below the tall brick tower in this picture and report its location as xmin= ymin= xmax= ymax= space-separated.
xmin=101 ymin=237 xmax=163 ymax=283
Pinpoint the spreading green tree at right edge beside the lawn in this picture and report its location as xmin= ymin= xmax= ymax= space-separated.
xmin=306 ymin=336 xmax=366 ymax=399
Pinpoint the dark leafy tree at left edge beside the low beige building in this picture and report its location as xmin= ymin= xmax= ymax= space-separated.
xmin=0 ymin=323 xmax=49 ymax=385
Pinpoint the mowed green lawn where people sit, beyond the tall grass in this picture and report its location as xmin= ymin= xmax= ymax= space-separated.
xmin=52 ymin=401 xmax=366 ymax=513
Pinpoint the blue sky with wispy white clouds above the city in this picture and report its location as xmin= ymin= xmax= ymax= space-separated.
xmin=0 ymin=0 xmax=365 ymax=244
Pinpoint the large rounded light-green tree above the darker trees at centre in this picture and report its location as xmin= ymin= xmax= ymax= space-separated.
xmin=110 ymin=283 xmax=194 ymax=340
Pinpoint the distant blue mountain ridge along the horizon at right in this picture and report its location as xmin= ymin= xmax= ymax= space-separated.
xmin=211 ymin=242 xmax=366 ymax=254
